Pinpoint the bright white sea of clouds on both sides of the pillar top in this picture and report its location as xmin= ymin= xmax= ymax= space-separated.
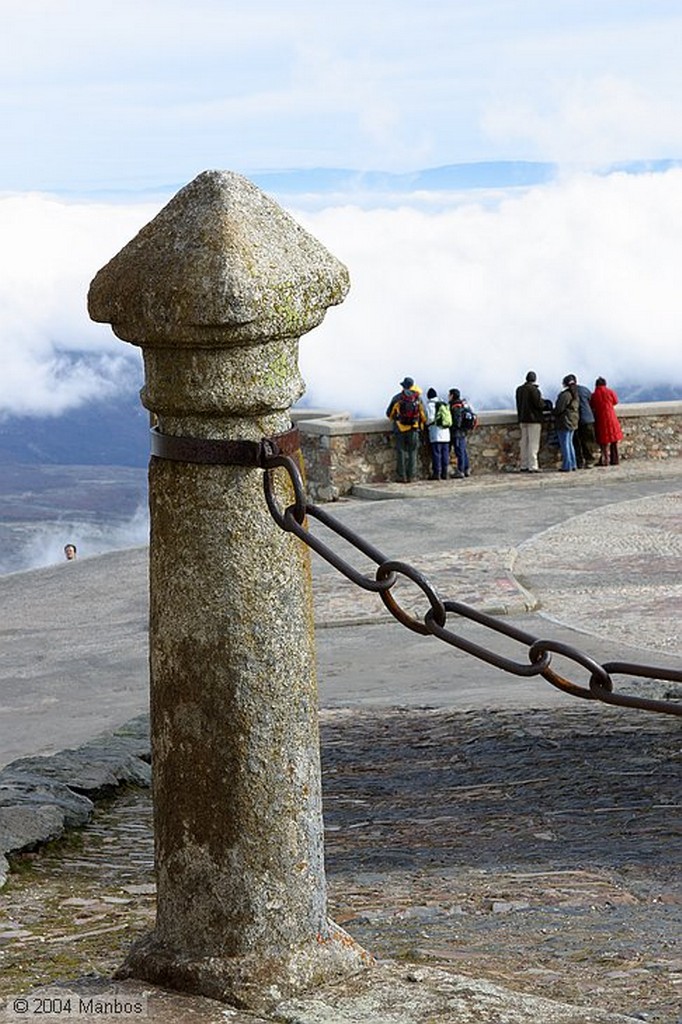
xmin=0 ymin=169 xmax=682 ymax=418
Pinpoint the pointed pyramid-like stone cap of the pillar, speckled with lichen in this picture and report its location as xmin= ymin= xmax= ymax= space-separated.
xmin=88 ymin=171 xmax=349 ymax=348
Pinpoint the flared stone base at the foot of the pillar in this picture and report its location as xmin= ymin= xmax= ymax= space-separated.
xmin=115 ymin=922 xmax=374 ymax=1013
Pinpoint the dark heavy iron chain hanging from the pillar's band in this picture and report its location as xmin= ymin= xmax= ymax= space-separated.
xmin=263 ymin=454 xmax=682 ymax=715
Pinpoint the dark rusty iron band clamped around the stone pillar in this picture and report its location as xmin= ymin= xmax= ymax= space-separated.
xmin=151 ymin=427 xmax=300 ymax=469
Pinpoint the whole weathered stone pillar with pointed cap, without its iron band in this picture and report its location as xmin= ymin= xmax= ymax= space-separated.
xmin=88 ymin=171 xmax=368 ymax=1010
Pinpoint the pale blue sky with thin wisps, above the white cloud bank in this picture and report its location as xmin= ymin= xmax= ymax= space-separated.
xmin=0 ymin=0 xmax=682 ymax=191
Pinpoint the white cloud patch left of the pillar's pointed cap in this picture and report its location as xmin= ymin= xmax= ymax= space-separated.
xmin=0 ymin=195 xmax=157 ymax=416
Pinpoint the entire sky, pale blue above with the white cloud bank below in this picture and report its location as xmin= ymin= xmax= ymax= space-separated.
xmin=0 ymin=0 xmax=682 ymax=422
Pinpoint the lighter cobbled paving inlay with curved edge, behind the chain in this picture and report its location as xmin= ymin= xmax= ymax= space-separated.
xmin=314 ymin=492 xmax=682 ymax=654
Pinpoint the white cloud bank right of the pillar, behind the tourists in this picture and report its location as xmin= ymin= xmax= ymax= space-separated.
xmin=299 ymin=171 xmax=682 ymax=415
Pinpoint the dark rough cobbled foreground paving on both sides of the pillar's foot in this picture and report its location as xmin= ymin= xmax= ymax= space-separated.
xmin=0 ymin=707 xmax=682 ymax=1024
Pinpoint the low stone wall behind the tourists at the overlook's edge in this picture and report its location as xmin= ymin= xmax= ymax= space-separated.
xmin=294 ymin=401 xmax=682 ymax=502
